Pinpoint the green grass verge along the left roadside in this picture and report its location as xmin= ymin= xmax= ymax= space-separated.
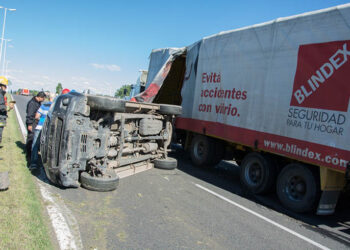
xmin=0 ymin=94 xmax=54 ymax=249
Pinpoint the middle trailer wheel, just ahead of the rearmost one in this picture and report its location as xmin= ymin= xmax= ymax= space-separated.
xmin=240 ymin=152 xmax=276 ymax=194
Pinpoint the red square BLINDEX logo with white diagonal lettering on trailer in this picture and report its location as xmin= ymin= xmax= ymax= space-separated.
xmin=290 ymin=40 xmax=350 ymax=112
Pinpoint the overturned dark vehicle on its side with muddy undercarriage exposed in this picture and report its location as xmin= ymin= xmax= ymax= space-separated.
xmin=40 ymin=92 xmax=181 ymax=191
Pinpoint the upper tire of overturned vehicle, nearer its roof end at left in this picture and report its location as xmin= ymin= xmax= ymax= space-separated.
xmin=87 ymin=95 xmax=125 ymax=112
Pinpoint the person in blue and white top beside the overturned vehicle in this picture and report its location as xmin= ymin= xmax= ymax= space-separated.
xmin=29 ymin=94 xmax=55 ymax=170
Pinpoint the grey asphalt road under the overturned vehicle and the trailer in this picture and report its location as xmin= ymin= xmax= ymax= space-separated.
xmin=15 ymin=96 xmax=350 ymax=249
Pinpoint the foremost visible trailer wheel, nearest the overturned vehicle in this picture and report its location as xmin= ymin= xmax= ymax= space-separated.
xmin=190 ymin=135 xmax=216 ymax=167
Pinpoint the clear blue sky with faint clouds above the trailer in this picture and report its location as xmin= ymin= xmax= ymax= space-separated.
xmin=0 ymin=0 xmax=348 ymax=94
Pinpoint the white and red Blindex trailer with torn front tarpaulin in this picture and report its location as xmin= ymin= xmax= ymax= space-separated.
xmin=134 ymin=4 xmax=350 ymax=214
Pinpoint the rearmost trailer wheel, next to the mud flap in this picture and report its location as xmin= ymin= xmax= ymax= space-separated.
xmin=277 ymin=163 xmax=319 ymax=213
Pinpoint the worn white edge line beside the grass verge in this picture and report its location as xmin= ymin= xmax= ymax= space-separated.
xmin=11 ymin=95 xmax=83 ymax=250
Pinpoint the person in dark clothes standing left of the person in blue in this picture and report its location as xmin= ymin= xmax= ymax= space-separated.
xmin=26 ymin=91 xmax=46 ymax=162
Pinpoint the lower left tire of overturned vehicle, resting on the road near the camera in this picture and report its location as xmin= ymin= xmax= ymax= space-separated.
xmin=80 ymin=169 xmax=119 ymax=192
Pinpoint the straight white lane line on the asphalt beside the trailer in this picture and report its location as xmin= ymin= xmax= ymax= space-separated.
xmin=194 ymin=183 xmax=329 ymax=250
